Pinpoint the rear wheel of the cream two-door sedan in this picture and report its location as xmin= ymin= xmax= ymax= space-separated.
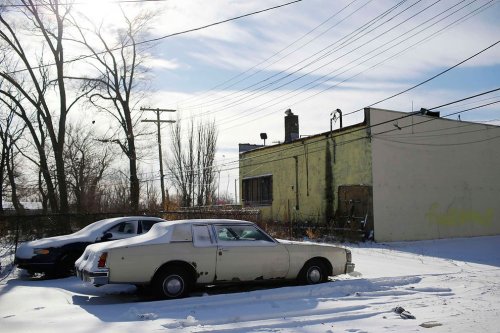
xmin=153 ymin=267 xmax=192 ymax=299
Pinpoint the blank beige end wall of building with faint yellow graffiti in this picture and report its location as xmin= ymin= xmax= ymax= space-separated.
xmin=370 ymin=109 xmax=500 ymax=241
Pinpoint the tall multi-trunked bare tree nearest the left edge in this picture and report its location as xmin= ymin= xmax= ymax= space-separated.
xmin=0 ymin=0 xmax=85 ymax=212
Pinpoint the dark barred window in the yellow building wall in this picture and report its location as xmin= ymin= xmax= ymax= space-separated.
xmin=242 ymin=175 xmax=273 ymax=206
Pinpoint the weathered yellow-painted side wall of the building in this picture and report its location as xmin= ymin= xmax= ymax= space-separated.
xmin=240 ymin=125 xmax=372 ymax=223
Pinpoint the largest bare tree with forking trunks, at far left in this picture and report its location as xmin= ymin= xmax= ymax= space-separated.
xmin=0 ymin=0 xmax=85 ymax=212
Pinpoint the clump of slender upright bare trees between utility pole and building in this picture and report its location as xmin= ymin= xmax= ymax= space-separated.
xmin=166 ymin=121 xmax=217 ymax=207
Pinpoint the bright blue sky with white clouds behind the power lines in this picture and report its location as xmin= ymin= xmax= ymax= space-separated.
xmin=3 ymin=0 xmax=500 ymax=197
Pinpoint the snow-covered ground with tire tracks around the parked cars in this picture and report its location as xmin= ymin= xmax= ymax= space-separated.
xmin=0 ymin=236 xmax=500 ymax=333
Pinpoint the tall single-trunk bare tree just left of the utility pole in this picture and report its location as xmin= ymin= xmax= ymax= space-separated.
xmin=71 ymin=13 xmax=156 ymax=211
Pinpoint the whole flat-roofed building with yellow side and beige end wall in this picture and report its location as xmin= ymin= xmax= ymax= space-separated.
xmin=239 ymin=108 xmax=500 ymax=241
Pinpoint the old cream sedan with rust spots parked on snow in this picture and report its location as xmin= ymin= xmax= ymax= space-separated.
xmin=75 ymin=220 xmax=354 ymax=298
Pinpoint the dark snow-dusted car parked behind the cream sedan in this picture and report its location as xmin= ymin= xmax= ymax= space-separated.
xmin=15 ymin=216 xmax=165 ymax=277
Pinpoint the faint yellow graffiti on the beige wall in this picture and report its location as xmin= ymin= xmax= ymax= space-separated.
xmin=425 ymin=203 xmax=493 ymax=226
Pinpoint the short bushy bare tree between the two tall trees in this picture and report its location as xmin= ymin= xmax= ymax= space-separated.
xmin=64 ymin=125 xmax=115 ymax=212
